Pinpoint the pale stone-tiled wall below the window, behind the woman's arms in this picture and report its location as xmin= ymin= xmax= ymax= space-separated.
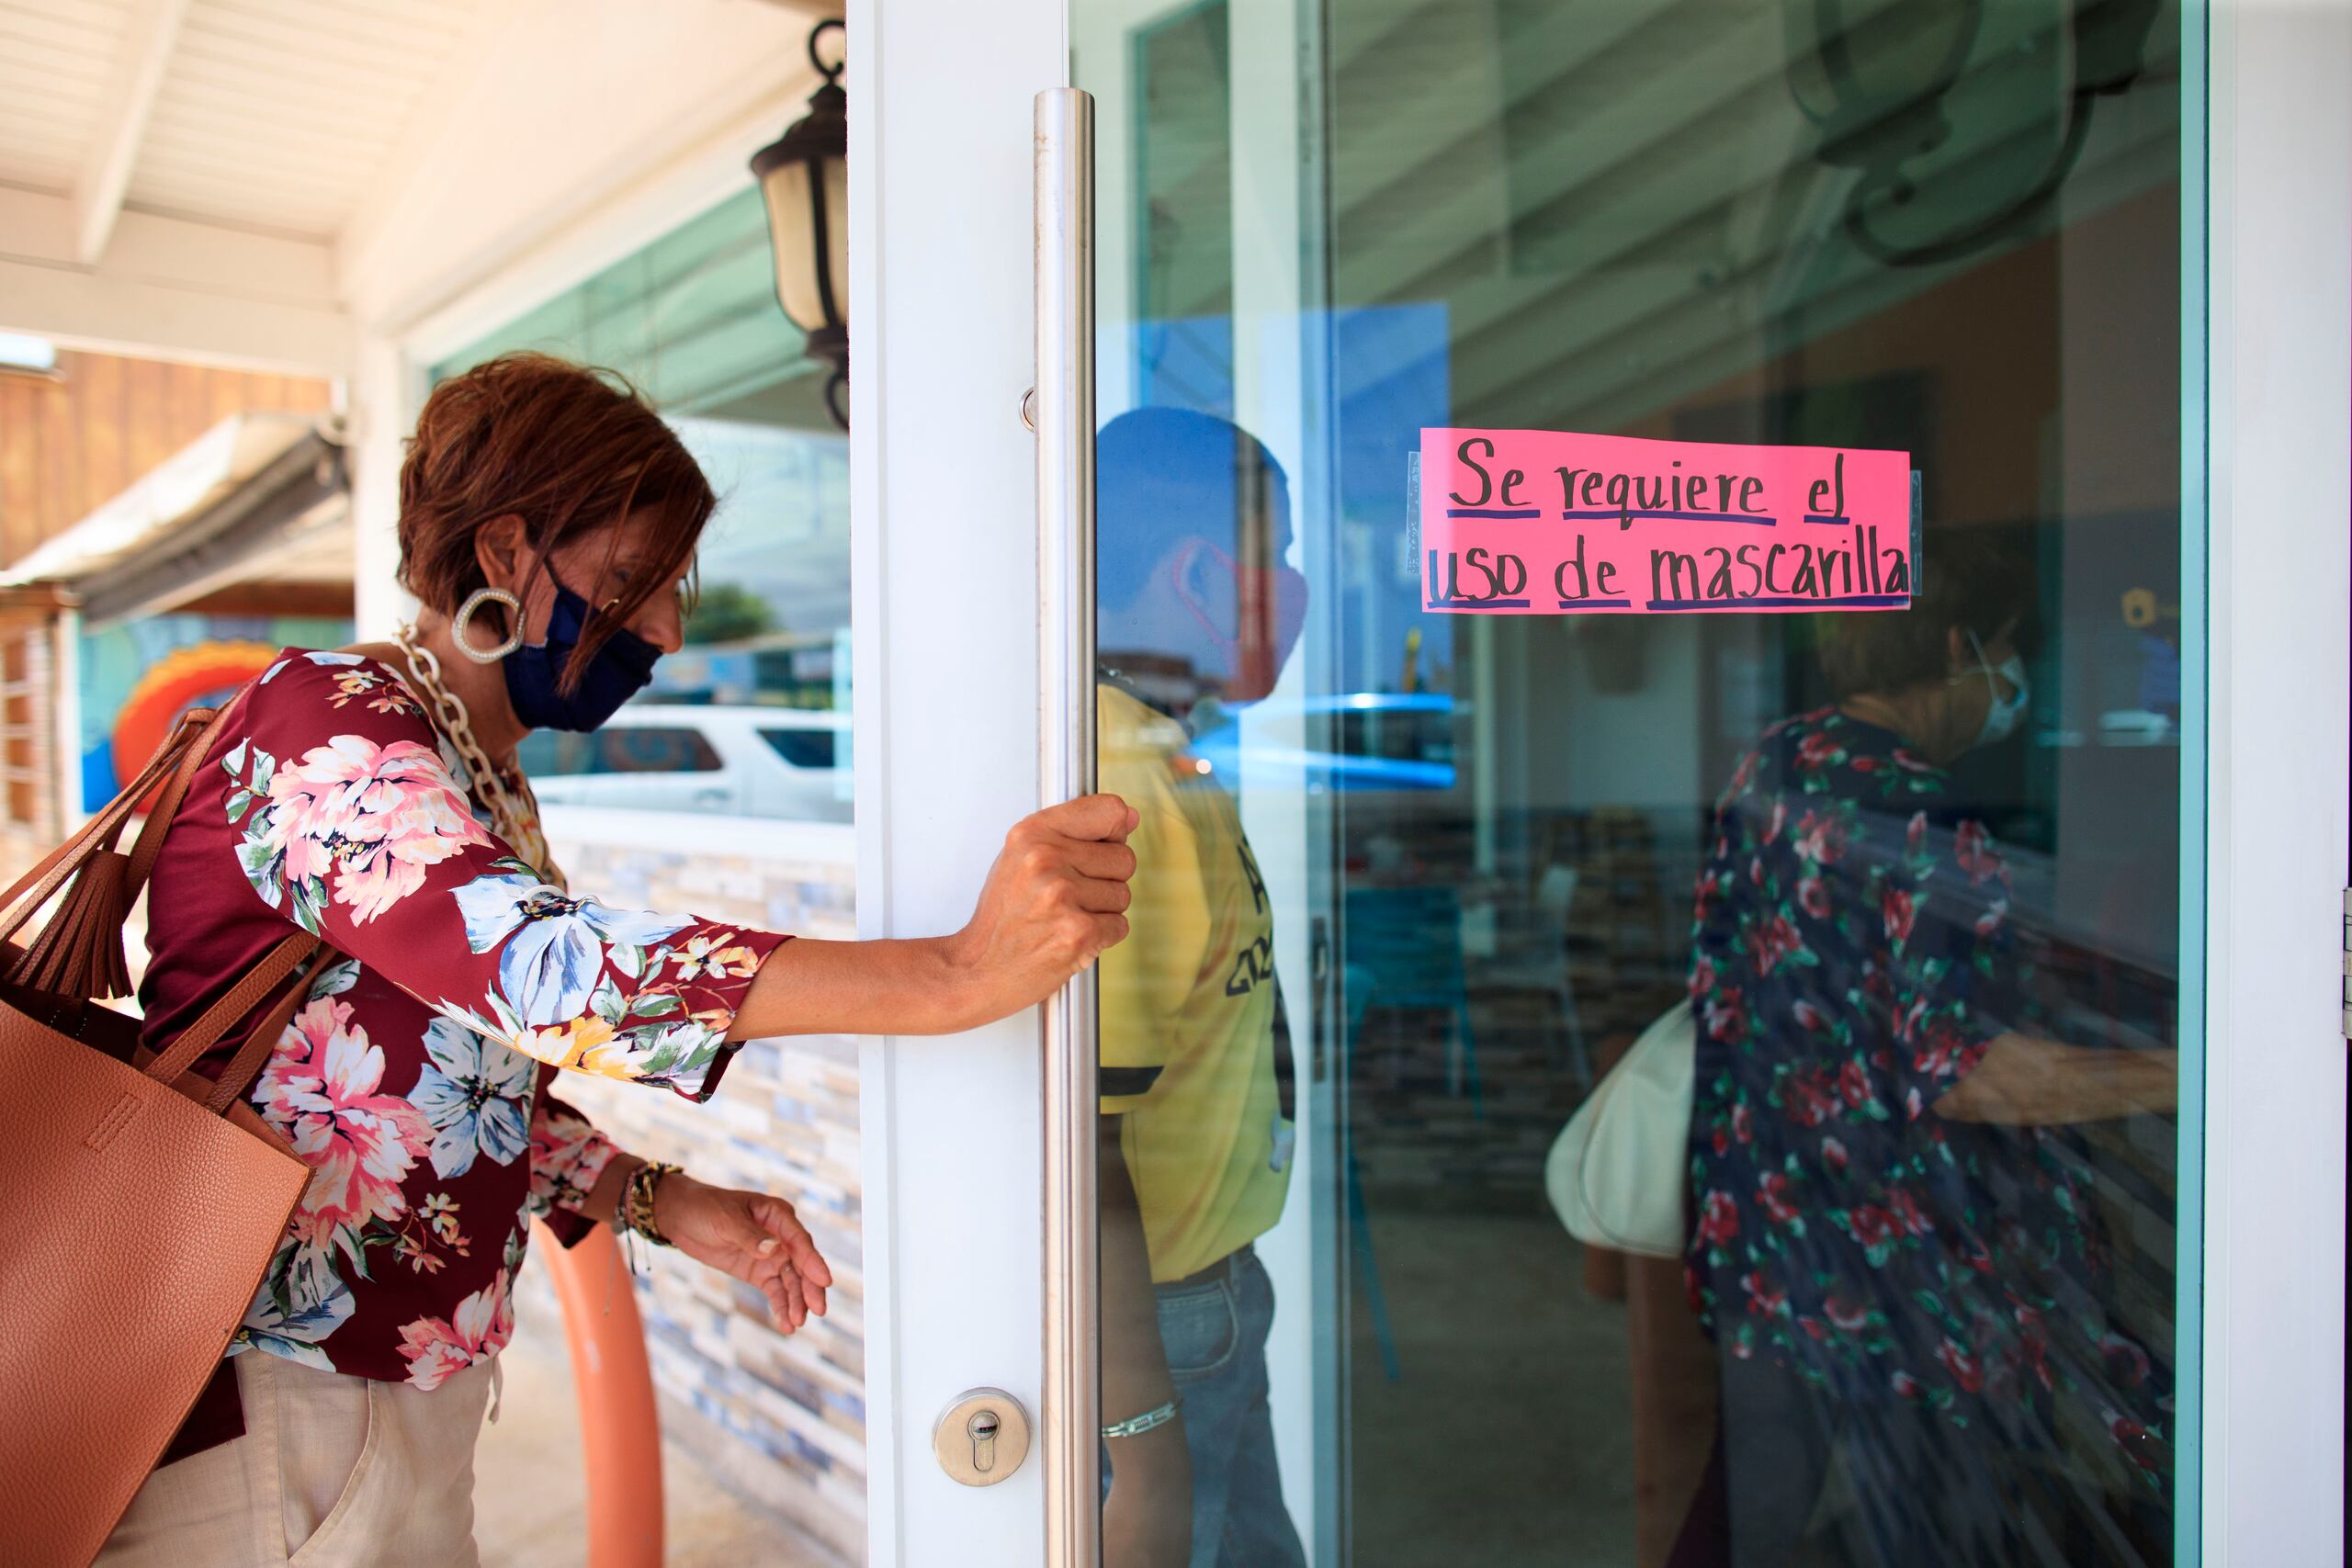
xmin=525 ymin=808 xmax=865 ymax=1563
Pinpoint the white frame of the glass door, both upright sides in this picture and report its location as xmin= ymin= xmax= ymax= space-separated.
xmin=849 ymin=0 xmax=2352 ymax=1568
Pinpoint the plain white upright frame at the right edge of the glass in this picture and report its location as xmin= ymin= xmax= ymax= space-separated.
xmin=2180 ymin=3 xmax=2352 ymax=1568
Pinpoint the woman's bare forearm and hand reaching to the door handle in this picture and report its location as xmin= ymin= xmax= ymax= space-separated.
xmin=727 ymin=795 xmax=1136 ymax=1039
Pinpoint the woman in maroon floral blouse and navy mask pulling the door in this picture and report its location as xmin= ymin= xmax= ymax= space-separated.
xmin=99 ymin=355 xmax=1134 ymax=1568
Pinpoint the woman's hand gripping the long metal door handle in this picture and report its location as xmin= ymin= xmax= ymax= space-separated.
xmin=945 ymin=795 xmax=1136 ymax=1022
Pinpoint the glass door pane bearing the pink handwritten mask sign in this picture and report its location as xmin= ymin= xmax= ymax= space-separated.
xmin=1070 ymin=0 xmax=2204 ymax=1568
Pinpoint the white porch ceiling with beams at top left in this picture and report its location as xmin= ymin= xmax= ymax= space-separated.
xmin=0 ymin=0 xmax=837 ymax=376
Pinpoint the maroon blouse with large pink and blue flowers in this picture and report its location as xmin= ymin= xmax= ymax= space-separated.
xmin=141 ymin=651 xmax=786 ymax=1419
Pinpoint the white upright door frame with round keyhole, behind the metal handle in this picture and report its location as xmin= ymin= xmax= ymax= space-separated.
xmin=847 ymin=0 xmax=1066 ymax=1568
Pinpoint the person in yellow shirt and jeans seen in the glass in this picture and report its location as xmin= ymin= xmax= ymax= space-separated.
xmin=1096 ymin=409 xmax=1306 ymax=1568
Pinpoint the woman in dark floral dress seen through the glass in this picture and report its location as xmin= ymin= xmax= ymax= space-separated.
xmin=1675 ymin=536 xmax=2176 ymax=1568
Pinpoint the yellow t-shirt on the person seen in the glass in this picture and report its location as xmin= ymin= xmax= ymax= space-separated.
xmin=1093 ymin=684 xmax=1291 ymax=1283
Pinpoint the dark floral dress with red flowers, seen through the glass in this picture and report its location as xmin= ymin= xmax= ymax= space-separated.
xmin=1687 ymin=710 xmax=2171 ymax=1481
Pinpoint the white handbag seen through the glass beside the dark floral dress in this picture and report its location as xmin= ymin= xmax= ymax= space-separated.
xmin=1543 ymin=1001 xmax=1698 ymax=1258
